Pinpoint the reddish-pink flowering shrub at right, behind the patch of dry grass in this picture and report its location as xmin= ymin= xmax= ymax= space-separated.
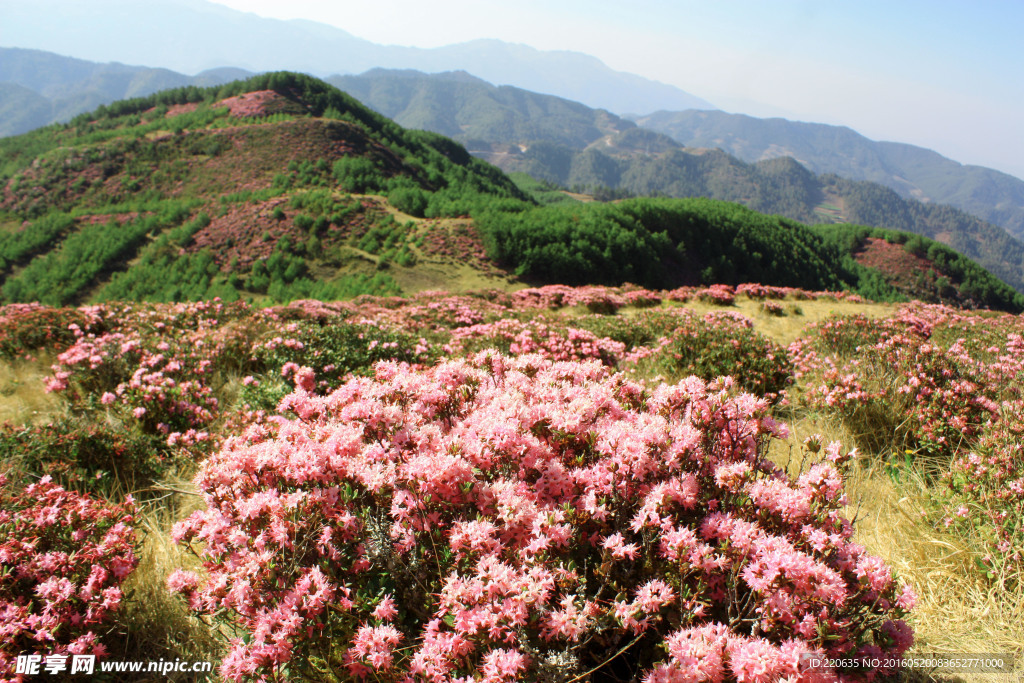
xmin=791 ymin=307 xmax=1001 ymax=459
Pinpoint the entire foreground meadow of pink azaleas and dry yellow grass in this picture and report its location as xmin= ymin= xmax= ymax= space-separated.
xmin=0 ymin=285 xmax=1024 ymax=683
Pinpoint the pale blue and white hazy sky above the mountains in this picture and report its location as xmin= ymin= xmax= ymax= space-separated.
xmin=207 ymin=0 xmax=1024 ymax=178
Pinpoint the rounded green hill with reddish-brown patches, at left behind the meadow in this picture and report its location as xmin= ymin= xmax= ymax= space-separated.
xmin=0 ymin=74 xmax=524 ymax=303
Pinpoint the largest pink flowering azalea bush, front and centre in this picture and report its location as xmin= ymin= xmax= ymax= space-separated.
xmin=174 ymin=352 xmax=912 ymax=683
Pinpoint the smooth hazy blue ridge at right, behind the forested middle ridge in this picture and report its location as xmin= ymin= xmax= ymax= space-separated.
xmin=633 ymin=111 xmax=1024 ymax=240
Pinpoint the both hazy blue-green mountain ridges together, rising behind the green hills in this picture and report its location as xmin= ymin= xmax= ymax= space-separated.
xmin=328 ymin=70 xmax=1024 ymax=249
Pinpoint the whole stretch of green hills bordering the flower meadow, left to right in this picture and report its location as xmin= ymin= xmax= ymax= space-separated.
xmin=0 ymin=73 xmax=1024 ymax=310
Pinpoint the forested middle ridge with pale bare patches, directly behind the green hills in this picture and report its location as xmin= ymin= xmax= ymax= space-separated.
xmin=331 ymin=70 xmax=1024 ymax=291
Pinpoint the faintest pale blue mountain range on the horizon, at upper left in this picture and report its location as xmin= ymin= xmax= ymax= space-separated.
xmin=0 ymin=0 xmax=713 ymax=113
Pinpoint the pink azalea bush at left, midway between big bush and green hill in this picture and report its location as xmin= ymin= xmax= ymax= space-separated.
xmin=46 ymin=301 xmax=265 ymax=455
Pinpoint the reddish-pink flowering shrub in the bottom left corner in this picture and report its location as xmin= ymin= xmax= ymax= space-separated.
xmin=0 ymin=475 xmax=137 ymax=681
